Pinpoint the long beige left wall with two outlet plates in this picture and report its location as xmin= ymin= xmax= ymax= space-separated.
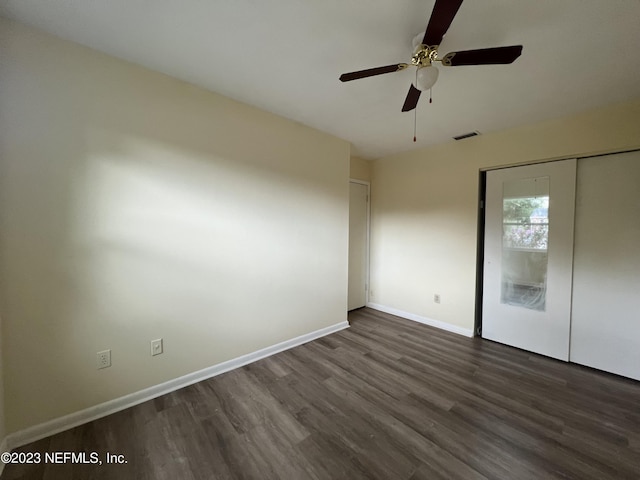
xmin=0 ymin=19 xmax=350 ymax=433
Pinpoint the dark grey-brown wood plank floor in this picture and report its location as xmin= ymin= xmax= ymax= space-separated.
xmin=2 ymin=309 xmax=640 ymax=480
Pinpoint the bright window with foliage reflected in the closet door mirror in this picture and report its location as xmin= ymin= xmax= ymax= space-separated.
xmin=502 ymin=196 xmax=549 ymax=250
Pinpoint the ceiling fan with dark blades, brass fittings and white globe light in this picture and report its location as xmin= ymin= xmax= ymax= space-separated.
xmin=340 ymin=0 xmax=522 ymax=112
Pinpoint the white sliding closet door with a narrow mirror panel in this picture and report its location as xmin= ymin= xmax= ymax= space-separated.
xmin=482 ymin=160 xmax=576 ymax=361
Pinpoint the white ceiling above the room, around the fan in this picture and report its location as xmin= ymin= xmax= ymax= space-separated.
xmin=0 ymin=0 xmax=640 ymax=158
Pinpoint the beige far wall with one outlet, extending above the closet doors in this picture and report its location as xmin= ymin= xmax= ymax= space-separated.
xmin=370 ymin=100 xmax=640 ymax=329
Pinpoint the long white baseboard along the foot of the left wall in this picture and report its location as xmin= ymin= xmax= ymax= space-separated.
xmin=1 ymin=320 xmax=349 ymax=451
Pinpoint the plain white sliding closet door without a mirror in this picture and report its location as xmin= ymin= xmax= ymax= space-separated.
xmin=571 ymin=152 xmax=640 ymax=380
